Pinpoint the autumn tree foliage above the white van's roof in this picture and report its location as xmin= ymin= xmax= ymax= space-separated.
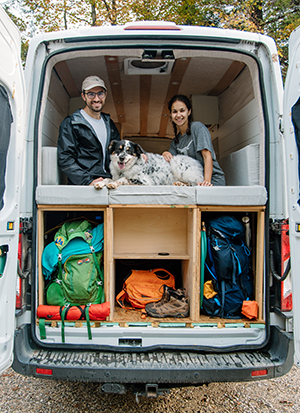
xmin=4 ymin=0 xmax=300 ymax=74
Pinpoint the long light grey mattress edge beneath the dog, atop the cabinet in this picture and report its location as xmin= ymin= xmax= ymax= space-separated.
xmin=36 ymin=185 xmax=268 ymax=206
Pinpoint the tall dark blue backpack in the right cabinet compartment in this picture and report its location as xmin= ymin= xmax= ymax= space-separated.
xmin=201 ymin=215 xmax=253 ymax=318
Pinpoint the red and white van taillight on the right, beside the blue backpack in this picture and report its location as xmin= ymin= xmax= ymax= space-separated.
xmin=281 ymin=220 xmax=293 ymax=311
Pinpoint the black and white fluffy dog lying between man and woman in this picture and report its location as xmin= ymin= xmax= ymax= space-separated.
xmin=94 ymin=140 xmax=203 ymax=189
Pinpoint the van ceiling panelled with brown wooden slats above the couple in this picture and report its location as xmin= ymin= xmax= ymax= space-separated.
xmin=52 ymin=51 xmax=245 ymax=138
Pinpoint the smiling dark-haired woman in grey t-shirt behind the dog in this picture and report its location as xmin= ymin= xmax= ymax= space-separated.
xmin=163 ymin=95 xmax=225 ymax=186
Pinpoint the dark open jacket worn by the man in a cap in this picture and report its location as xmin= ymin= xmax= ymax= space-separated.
xmin=57 ymin=109 xmax=120 ymax=185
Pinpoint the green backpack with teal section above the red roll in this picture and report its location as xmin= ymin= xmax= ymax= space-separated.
xmin=46 ymin=220 xmax=105 ymax=306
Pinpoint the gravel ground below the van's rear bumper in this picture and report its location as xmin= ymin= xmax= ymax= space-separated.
xmin=0 ymin=367 xmax=300 ymax=413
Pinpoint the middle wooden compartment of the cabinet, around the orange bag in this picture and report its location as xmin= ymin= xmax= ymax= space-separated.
xmin=105 ymin=205 xmax=200 ymax=321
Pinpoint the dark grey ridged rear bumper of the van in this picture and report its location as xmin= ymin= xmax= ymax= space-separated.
xmin=12 ymin=325 xmax=294 ymax=393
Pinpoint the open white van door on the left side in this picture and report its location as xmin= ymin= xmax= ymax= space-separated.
xmin=0 ymin=7 xmax=25 ymax=373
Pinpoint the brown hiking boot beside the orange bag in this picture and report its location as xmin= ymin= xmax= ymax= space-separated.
xmin=145 ymin=285 xmax=189 ymax=318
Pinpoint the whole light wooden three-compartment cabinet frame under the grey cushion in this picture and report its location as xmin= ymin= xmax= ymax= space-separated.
xmin=37 ymin=205 xmax=264 ymax=325
